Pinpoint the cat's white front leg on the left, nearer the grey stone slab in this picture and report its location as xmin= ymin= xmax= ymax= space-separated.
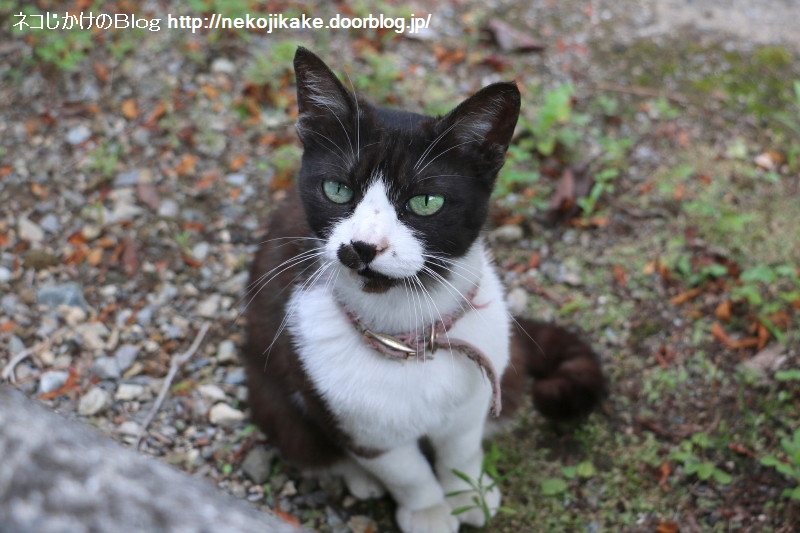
xmin=356 ymin=442 xmax=459 ymax=533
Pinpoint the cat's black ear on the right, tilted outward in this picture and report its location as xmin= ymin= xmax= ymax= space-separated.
xmin=439 ymin=82 xmax=520 ymax=170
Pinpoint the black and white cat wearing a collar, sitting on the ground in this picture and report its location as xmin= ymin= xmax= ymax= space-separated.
xmin=244 ymin=47 xmax=605 ymax=533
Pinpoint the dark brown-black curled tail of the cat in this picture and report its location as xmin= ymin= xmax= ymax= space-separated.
xmin=502 ymin=318 xmax=607 ymax=420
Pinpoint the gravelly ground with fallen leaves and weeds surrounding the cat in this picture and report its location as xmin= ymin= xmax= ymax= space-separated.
xmin=0 ymin=0 xmax=800 ymax=533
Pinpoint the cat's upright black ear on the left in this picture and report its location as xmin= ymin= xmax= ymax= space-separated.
xmin=294 ymin=46 xmax=353 ymax=123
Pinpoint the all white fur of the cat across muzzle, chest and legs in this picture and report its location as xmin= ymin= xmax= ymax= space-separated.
xmin=289 ymin=180 xmax=510 ymax=533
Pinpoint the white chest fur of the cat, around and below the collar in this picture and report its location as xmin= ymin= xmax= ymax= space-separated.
xmin=289 ymin=243 xmax=510 ymax=450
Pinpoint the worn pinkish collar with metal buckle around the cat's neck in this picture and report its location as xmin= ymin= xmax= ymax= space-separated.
xmin=339 ymin=287 xmax=502 ymax=417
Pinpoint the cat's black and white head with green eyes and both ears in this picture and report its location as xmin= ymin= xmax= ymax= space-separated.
xmin=294 ymin=48 xmax=520 ymax=292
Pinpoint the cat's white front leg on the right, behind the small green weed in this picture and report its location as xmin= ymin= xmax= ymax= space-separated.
xmin=430 ymin=400 xmax=501 ymax=527
